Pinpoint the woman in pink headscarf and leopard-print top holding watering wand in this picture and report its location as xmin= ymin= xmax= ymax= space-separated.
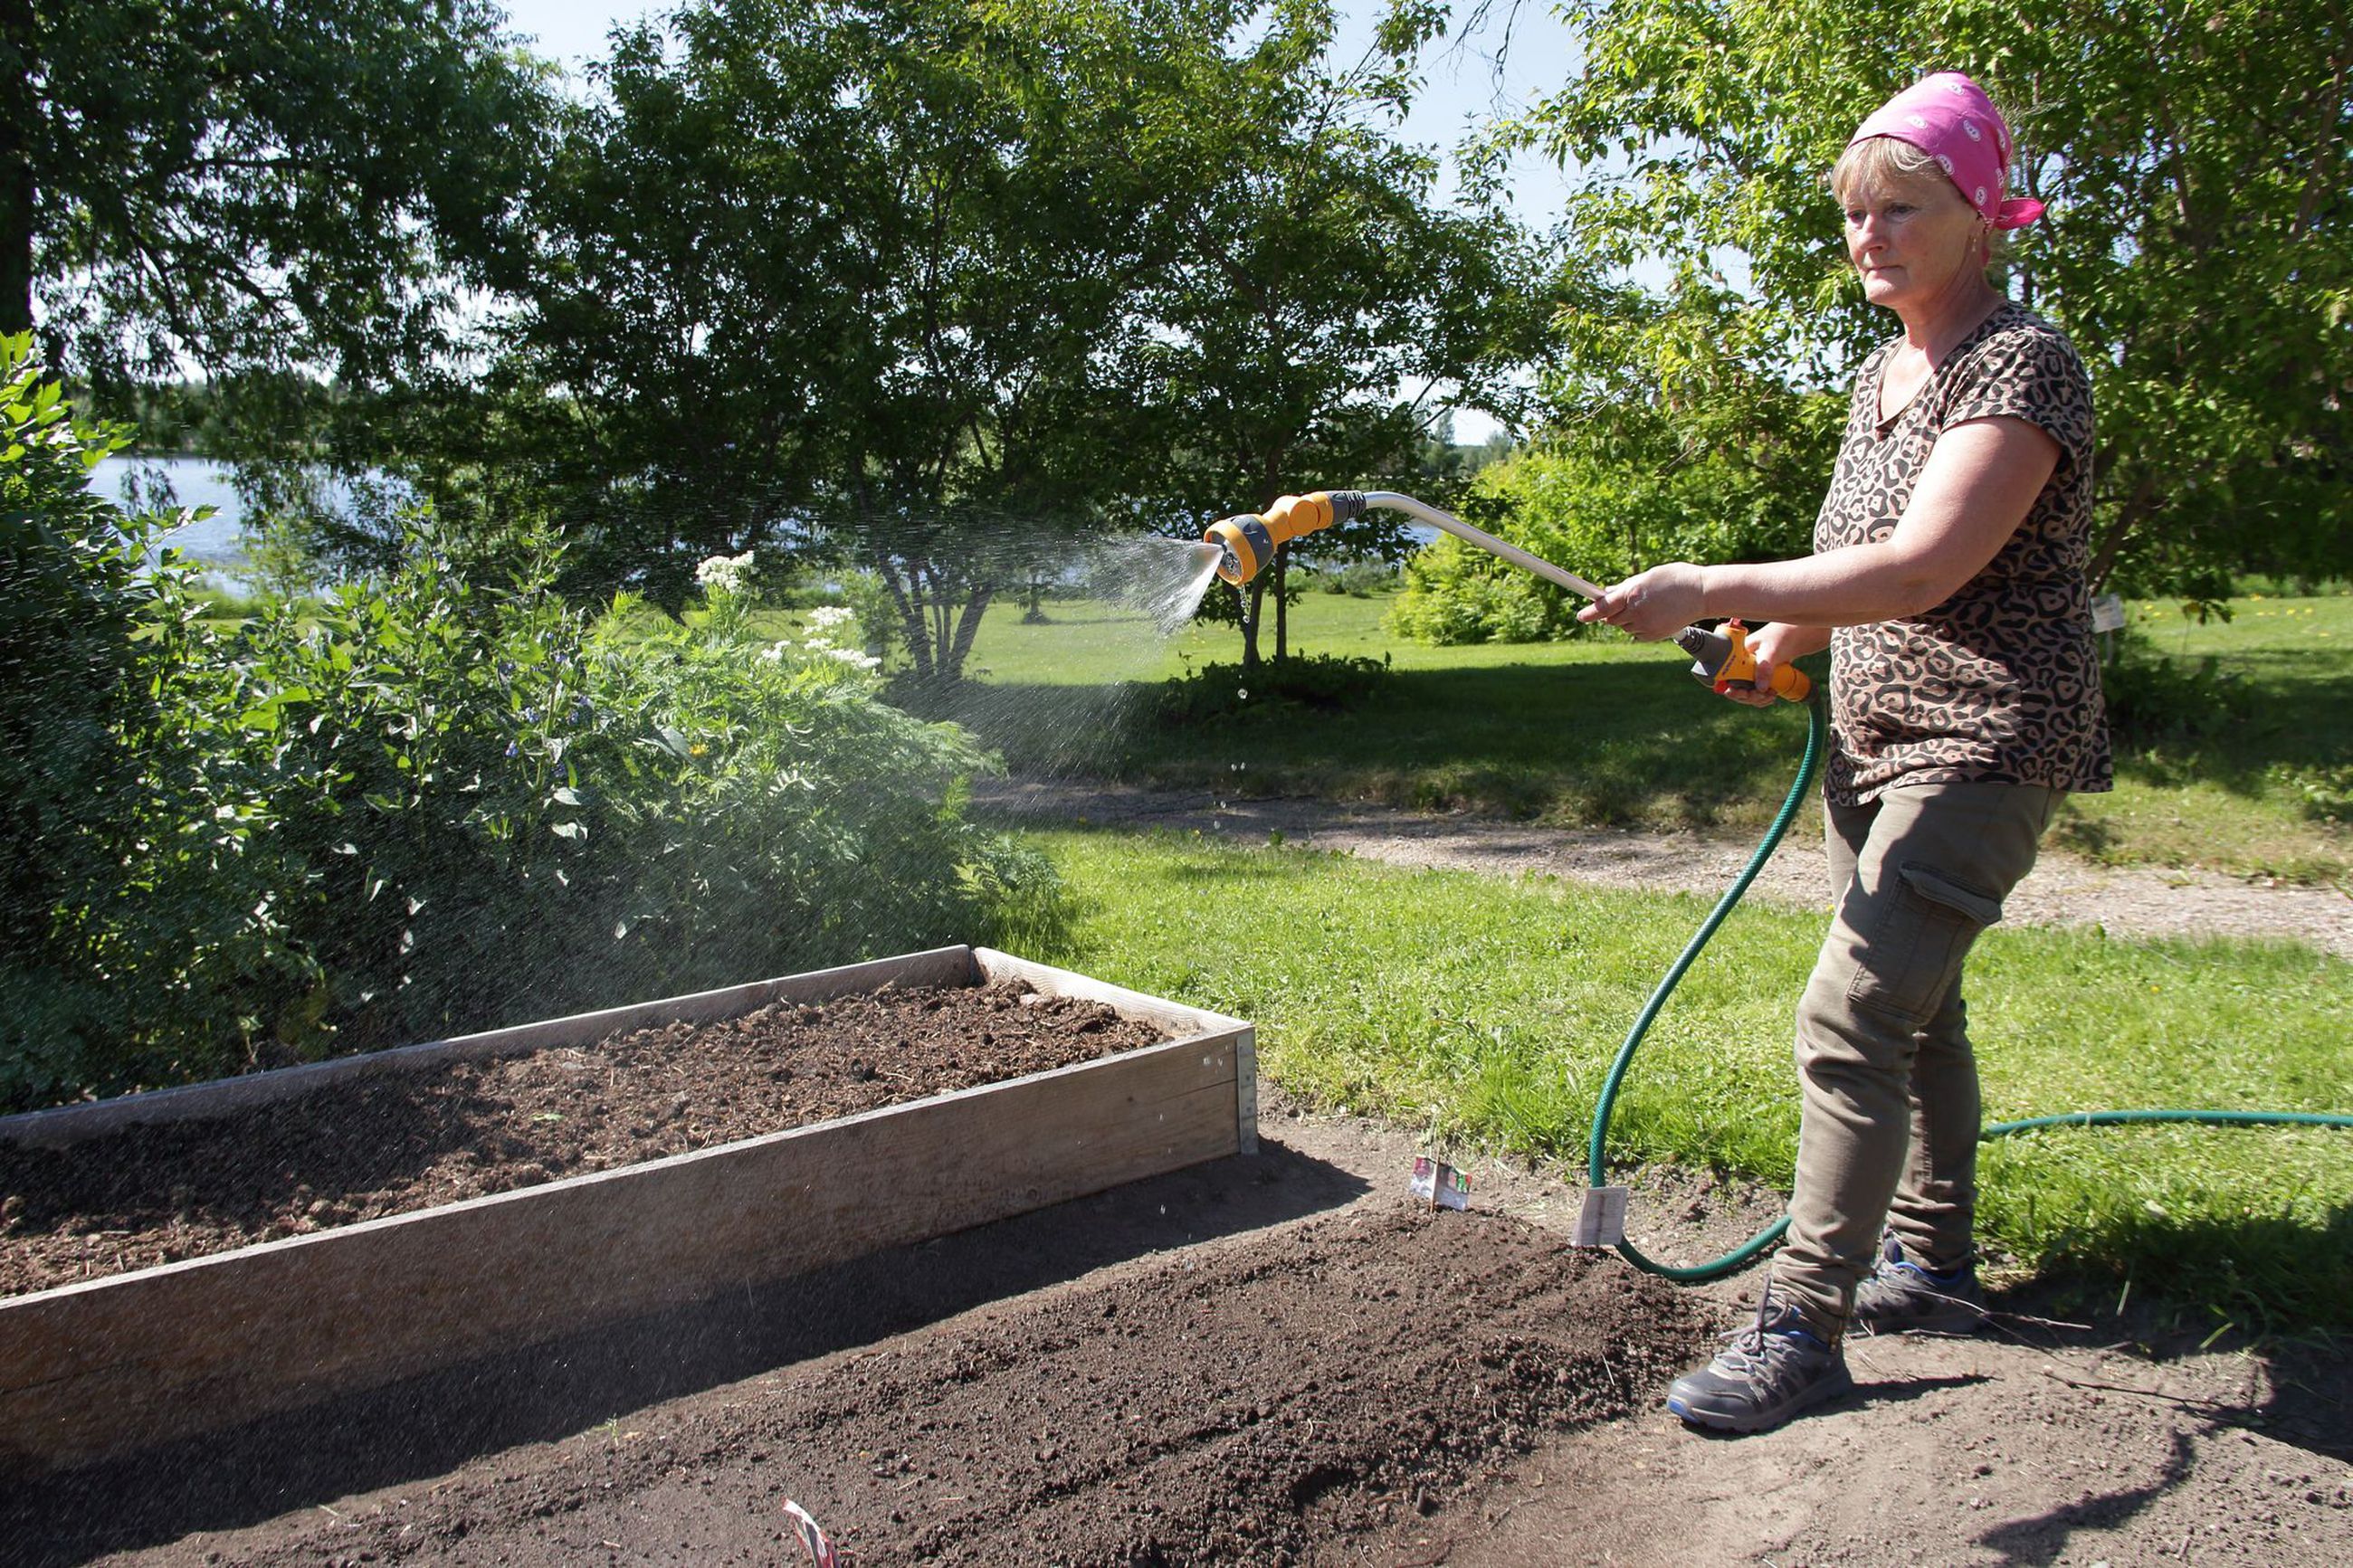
xmin=1579 ymin=73 xmax=2110 ymax=1431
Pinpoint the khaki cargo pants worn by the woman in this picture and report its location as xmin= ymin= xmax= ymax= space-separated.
xmin=1772 ymin=783 xmax=2063 ymax=1335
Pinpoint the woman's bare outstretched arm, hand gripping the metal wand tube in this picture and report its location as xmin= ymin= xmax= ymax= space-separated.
xmin=1577 ymin=416 xmax=2059 ymax=640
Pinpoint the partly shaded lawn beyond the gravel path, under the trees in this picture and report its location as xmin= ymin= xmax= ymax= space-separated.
xmin=953 ymin=580 xmax=2353 ymax=881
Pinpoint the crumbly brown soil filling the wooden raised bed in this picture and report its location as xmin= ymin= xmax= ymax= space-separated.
xmin=0 ymin=983 xmax=1165 ymax=1296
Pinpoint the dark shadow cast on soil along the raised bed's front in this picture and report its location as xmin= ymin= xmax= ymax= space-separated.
xmin=14 ymin=1143 xmax=1367 ymax=1565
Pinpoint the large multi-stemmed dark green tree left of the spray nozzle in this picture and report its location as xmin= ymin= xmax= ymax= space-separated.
xmin=494 ymin=0 xmax=1226 ymax=639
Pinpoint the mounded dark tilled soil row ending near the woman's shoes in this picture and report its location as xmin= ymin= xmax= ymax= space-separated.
xmin=137 ymin=1203 xmax=1701 ymax=1565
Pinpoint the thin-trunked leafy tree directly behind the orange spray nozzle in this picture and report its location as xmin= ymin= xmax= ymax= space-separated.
xmin=1150 ymin=3 xmax=1546 ymax=668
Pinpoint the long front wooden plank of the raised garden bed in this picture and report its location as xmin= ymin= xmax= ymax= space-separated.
xmin=0 ymin=1034 xmax=1240 ymax=1469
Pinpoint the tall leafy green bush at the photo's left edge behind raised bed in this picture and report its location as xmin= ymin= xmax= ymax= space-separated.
xmin=0 ymin=337 xmax=315 ymax=1107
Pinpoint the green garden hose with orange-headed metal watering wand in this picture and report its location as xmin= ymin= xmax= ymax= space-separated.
xmin=1203 ymin=489 xmax=2353 ymax=1284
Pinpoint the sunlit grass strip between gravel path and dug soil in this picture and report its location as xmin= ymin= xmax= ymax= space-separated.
xmin=1005 ymin=832 xmax=2353 ymax=1328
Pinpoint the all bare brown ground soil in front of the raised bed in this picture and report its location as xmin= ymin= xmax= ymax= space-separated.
xmin=0 ymin=1084 xmax=2353 ymax=1568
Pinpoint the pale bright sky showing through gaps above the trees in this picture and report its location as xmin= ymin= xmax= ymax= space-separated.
xmin=489 ymin=0 xmax=1574 ymax=442
